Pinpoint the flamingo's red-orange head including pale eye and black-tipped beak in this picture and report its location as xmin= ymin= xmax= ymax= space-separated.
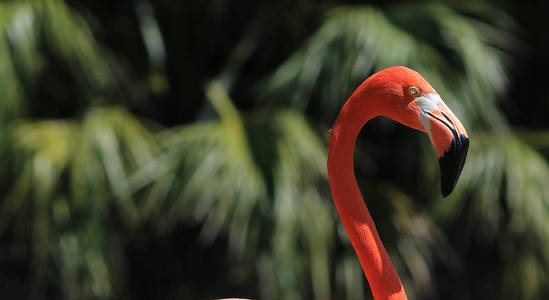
xmin=359 ymin=66 xmax=469 ymax=197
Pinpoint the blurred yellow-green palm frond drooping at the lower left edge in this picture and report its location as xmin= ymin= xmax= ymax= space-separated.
xmin=0 ymin=108 xmax=155 ymax=299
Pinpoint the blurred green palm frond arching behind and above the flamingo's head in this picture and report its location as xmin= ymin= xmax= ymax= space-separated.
xmin=264 ymin=3 xmax=507 ymax=128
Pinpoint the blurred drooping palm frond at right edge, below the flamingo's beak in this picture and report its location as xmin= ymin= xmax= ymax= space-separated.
xmin=434 ymin=133 xmax=549 ymax=298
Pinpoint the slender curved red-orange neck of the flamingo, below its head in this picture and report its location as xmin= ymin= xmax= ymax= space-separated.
xmin=328 ymin=95 xmax=407 ymax=300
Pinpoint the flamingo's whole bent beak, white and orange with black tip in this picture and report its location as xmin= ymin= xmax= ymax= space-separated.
xmin=415 ymin=94 xmax=469 ymax=197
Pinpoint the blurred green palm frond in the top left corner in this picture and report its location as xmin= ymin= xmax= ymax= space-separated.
xmin=0 ymin=0 xmax=118 ymax=124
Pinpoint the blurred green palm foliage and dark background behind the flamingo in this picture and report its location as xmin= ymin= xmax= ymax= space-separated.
xmin=0 ymin=0 xmax=549 ymax=299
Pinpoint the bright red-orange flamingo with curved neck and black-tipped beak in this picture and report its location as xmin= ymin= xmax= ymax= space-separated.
xmin=327 ymin=66 xmax=469 ymax=300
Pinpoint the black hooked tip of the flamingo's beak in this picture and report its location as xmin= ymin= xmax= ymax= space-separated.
xmin=438 ymin=134 xmax=469 ymax=197
